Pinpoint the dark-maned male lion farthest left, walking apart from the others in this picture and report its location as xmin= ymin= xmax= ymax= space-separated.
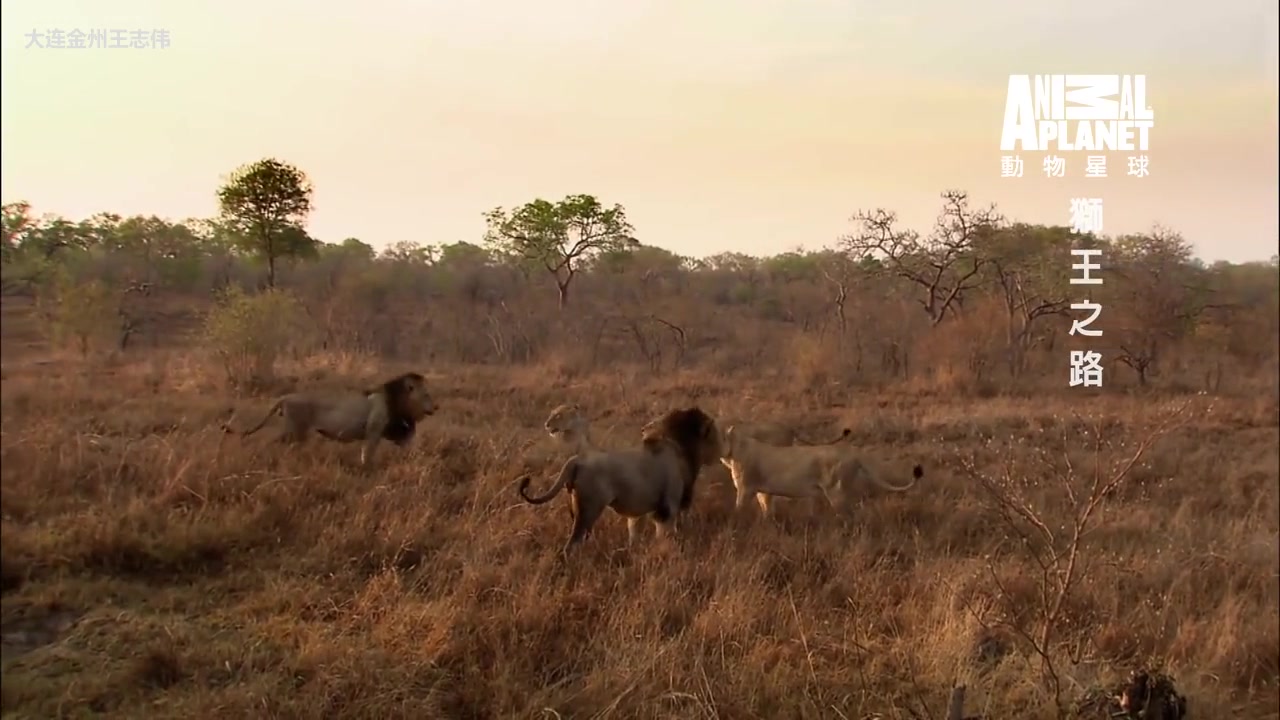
xmin=223 ymin=373 xmax=435 ymax=469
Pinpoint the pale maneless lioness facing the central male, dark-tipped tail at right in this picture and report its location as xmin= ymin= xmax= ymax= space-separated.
xmin=721 ymin=425 xmax=924 ymax=518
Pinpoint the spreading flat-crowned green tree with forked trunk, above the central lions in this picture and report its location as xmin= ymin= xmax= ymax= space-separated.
xmin=485 ymin=195 xmax=640 ymax=310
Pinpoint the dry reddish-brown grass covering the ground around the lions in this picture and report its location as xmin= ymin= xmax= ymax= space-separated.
xmin=0 ymin=345 xmax=1280 ymax=720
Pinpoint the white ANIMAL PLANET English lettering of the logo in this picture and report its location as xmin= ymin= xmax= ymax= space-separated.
xmin=1000 ymin=76 xmax=1156 ymax=152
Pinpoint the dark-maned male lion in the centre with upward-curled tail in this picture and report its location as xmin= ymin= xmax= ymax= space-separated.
xmin=518 ymin=407 xmax=722 ymax=555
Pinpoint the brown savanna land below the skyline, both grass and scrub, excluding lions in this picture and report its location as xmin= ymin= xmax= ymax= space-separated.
xmin=0 ymin=181 xmax=1280 ymax=719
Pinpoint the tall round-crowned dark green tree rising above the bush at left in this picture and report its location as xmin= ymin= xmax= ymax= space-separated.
xmin=218 ymin=158 xmax=316 ymax=287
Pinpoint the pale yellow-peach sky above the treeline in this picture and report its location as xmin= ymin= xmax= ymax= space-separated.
xmin=0 ymin=0 xmax=1280 ymax=261
